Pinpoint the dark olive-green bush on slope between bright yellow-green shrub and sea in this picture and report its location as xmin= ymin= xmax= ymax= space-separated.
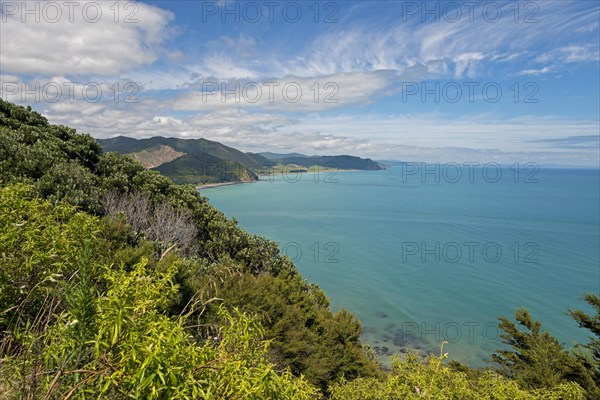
xmin=195 ymin=266 xmax=380 ymax=390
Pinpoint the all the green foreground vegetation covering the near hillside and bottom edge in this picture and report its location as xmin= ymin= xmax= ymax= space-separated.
xmin=0 ymin=100 xmax=600 ymax=399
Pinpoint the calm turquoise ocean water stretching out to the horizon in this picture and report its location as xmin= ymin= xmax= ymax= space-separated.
xmin=201 ymin=165 xmax=600 ymax=367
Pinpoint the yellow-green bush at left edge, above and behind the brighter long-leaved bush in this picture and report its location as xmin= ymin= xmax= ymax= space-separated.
xmin=0 ymin=185 xmax=103 ymax=331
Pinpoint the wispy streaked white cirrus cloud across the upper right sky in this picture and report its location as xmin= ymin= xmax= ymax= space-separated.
xmin=267 ymin=1 xmax=598 ymax=79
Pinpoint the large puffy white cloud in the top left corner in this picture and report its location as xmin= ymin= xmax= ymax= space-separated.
xmin=0 ymin=1 xmax=174 ymax=76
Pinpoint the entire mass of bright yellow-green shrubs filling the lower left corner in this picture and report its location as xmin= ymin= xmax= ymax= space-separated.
xmin=0 ymin=185 xmax=316 ymax=399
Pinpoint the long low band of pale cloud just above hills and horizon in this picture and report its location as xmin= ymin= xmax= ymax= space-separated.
xmin=31 ymin=93 xmax=599 ymax=165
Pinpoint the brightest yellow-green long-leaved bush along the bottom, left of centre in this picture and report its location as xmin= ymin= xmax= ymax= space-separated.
xmin=2 ymin=262 xmax=316 ymax=400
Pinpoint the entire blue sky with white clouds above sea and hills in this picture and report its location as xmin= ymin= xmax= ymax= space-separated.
xmin=0 ymin=0 xmax=600 ymax=166
